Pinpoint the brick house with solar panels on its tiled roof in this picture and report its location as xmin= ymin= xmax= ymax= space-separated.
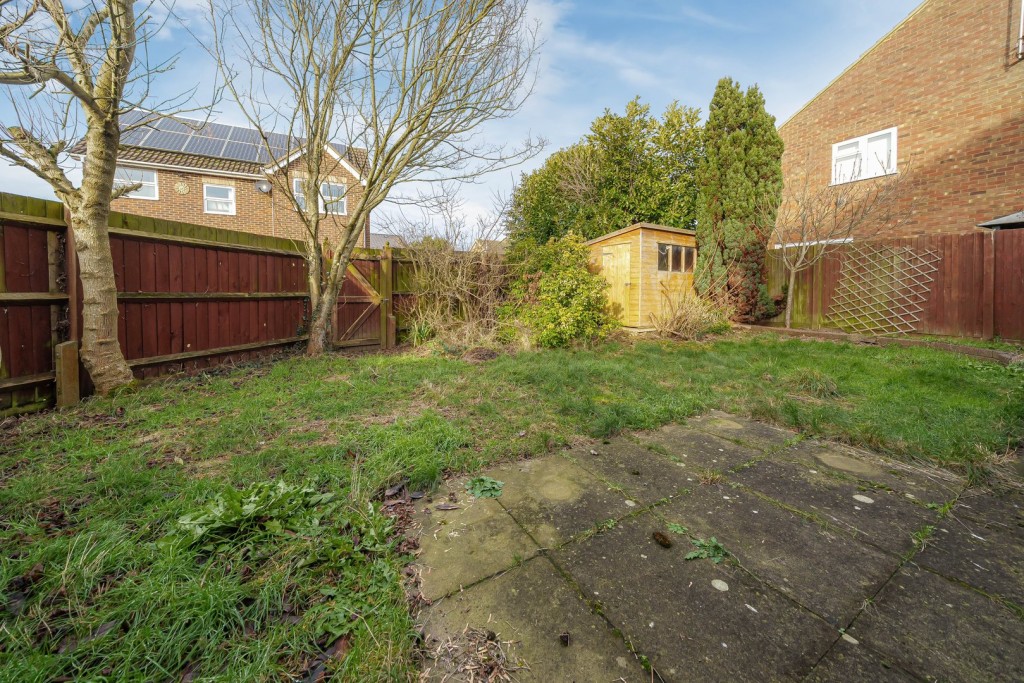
xmin=71 ymin=111 xmax=371 ymax=248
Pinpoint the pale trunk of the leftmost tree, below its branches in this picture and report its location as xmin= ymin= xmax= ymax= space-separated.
xmin=71 ymin=203 xmax=132 ymax=394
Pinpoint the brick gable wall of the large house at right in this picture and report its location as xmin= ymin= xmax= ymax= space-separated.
xmin=780 ymin=0 xmax=1024 ymax=236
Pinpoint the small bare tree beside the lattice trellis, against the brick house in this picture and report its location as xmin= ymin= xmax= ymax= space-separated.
xmin=772 ymin=162 xmax=910 ymax=328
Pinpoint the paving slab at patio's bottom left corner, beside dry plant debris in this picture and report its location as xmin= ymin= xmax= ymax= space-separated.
xmin=421 ymin=557 xmax=649 ymax=683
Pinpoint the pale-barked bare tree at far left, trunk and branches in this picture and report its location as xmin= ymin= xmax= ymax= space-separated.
xmin=0 ymin=0 xmax=197 ymax=393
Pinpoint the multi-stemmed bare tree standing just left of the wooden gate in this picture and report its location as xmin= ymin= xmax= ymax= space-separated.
xmin=210 ymin=0 xmax=540 ymax=355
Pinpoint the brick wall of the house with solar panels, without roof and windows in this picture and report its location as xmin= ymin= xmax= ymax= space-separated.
xmin=111 ymin=150 xmax=370 ymax=247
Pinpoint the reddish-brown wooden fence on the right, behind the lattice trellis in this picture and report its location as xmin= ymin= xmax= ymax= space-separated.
xmin=768 ymin=230 xmax=1024 ymax=340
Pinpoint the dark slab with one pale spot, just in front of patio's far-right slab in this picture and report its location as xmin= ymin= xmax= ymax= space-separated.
xmin=729 ymin=460 xmax=938 ymax=554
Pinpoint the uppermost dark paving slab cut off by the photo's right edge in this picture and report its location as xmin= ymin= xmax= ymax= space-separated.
xmin=914 ymin=492 xmax=1024 ymax=609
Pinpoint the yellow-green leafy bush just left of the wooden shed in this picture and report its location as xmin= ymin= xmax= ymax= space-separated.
xmin=503 ymin=232 xmax=617 ymax=348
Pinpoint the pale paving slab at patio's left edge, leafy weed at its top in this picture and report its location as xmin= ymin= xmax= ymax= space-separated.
xmin=414 ymin=480 xmax=540 ymax=600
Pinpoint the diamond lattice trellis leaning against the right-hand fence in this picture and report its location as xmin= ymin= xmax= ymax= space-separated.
xmin=825 ymin=243 xmax=941 ymax=336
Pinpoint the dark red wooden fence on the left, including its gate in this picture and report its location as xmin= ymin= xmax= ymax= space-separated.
xmin=0 ymin=193 xmax=409 ymax=415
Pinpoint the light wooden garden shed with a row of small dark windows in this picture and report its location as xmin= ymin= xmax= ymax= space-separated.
xmin=587 ymin=223 xmax=696 ymax=329
